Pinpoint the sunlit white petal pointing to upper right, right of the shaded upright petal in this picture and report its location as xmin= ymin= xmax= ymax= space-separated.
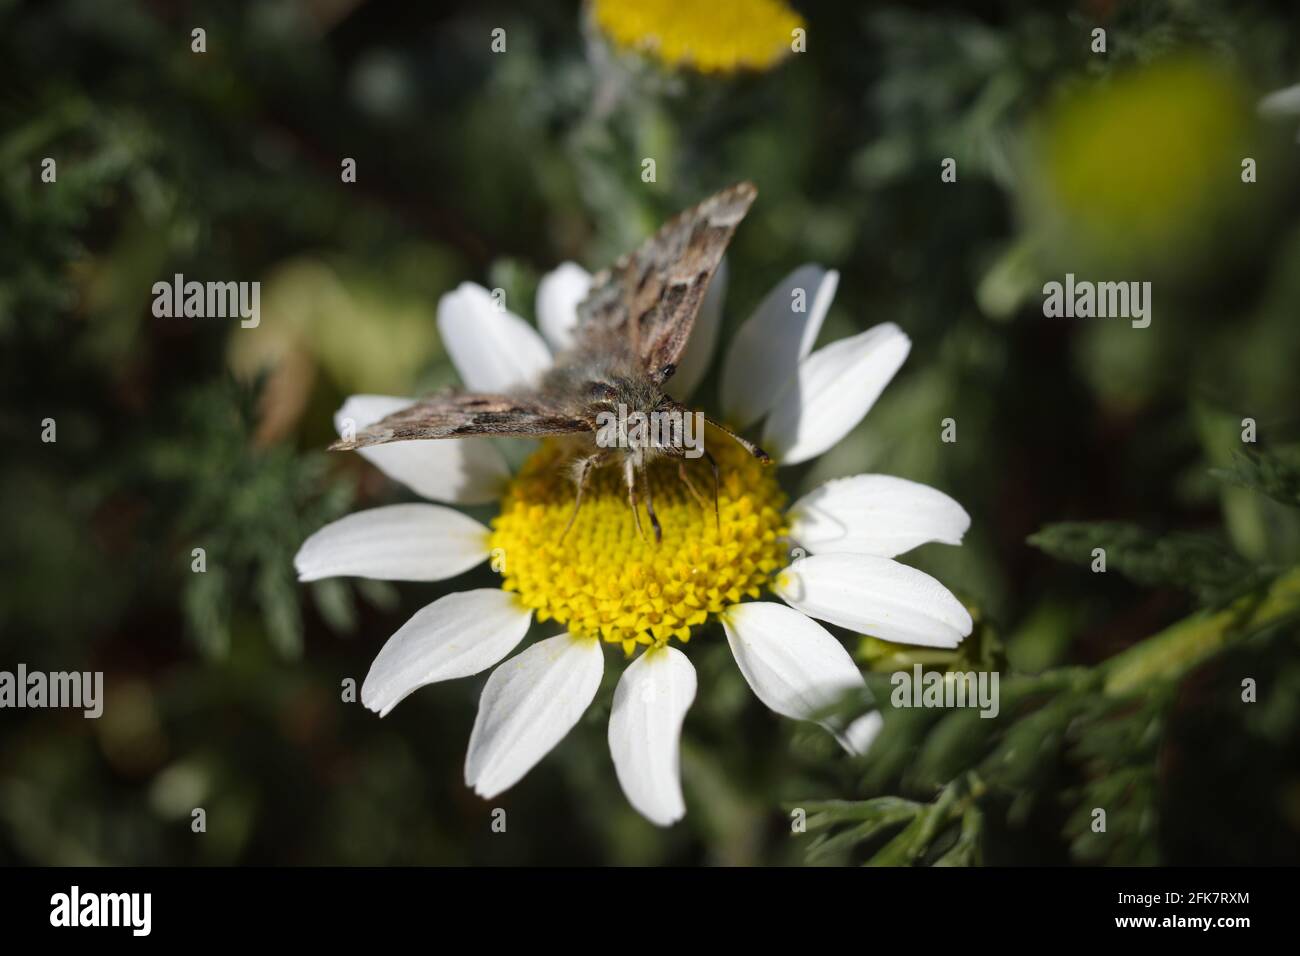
xmin=762 ymin=323 xmax=911 ymax=464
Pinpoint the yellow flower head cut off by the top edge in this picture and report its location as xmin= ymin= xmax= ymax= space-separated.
xmin=593 ymin=0 xmax=803 ymax=73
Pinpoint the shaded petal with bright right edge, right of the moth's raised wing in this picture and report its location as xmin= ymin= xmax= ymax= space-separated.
xmin=722 ymin=265 xmax=840 ymax=428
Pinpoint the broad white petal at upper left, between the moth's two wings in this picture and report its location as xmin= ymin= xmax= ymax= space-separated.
xmin=438 ymin=282 xmax=551 ymax=392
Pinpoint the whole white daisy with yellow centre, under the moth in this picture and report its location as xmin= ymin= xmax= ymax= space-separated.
xmin=295 ymin=264 xmax=971 ymax=826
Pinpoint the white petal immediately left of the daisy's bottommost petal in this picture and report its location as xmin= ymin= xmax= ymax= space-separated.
xmin=465 ymin=633 xmax=605 ymax=799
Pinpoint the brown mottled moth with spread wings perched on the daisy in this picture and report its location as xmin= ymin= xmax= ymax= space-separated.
xmin=330 ymin=182 xmax=770 ymax=540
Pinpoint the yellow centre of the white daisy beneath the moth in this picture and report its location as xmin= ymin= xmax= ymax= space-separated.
xmin=490 ymin=429 xmax=788 ymax=653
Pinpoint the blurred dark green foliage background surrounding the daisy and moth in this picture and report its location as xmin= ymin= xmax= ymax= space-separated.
xmin=0 ymin=0 xmax=1300 ymax=864
